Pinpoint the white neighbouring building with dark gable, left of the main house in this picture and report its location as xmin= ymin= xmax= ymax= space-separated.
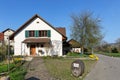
xmin=2 ymin=28 xmax=15 ymax=46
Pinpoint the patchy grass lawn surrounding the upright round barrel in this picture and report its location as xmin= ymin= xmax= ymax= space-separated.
xmin=44 ymin=58 xmax=96 ymax=80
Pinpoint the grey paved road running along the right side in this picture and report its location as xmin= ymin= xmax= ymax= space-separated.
xmin=85 ymin=54 xmax=120 ymax=80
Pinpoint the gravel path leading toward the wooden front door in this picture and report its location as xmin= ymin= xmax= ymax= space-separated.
xmin=25 ymin=57 xmax=55 ymax=80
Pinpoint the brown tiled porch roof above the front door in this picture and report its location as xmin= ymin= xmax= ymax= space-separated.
xmin=23 ymin=38 xmax=50 ymax=43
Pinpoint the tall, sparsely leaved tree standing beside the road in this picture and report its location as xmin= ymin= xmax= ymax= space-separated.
xmin=70 ymin=12 xmax=103 ymax=53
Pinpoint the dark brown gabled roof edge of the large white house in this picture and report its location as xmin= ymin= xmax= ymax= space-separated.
xmin=10 ymin=14 xmax=67 ymax=39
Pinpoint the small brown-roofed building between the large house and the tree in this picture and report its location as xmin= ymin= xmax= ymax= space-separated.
xmin=68 ymin=39 xmax=81 ymax=53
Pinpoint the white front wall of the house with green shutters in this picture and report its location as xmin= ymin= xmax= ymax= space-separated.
xmin=14 ymin=18 xmax=62 ymax=56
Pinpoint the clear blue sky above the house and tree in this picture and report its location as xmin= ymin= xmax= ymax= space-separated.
xmin=0 ymin=0 xmax=120 ymax=43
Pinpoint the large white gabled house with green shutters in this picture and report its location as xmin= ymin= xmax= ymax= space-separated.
xmin=10 ymin=14 xmax=67 ymax=56
